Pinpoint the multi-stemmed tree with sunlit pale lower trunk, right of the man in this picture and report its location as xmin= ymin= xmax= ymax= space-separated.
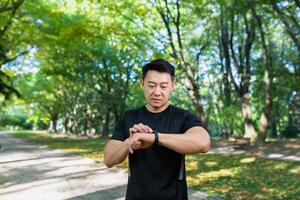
xmin=220 ymin=2 xmax=256 ymax=141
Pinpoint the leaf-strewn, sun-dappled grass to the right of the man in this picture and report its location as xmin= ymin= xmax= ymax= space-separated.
xmin=186 ymin=154 xmax=300 ymax=199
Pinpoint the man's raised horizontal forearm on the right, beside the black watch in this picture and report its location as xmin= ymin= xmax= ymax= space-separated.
xmin=159 ymin=129 xmax=210 ymax=154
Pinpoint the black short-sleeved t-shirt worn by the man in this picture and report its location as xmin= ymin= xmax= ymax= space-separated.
xmin=111 ymin=105 xmax=201 ymax=200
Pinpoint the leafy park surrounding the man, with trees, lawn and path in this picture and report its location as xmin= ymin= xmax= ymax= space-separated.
xmin=0 ymin=0 xmax=300 ymax=200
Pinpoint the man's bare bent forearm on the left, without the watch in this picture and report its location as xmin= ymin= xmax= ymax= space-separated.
xmin=104 ymin=139 xmax=129 ymax=168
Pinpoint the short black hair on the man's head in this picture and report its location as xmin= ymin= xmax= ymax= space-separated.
xmin=142 ymin=58 xmax=175 ymax=81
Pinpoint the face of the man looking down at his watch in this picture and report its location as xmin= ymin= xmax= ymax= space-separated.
xmin=141 ymin=70 xmax=174 ymax=112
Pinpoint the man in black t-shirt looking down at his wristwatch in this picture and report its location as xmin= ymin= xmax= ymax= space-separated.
xmin=104 ymin=59 xmax=210 ymax=200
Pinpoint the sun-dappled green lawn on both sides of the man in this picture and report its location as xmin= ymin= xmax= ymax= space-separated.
xmin=15 ymin=132 xmax=300 ymax=199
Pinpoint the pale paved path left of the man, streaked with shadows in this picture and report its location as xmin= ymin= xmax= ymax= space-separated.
xmin=0 ymin=132 xmax=217 ymax=200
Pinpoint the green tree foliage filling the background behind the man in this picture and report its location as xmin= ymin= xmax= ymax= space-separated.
xmin=0 ymin=0 xmax=300 ymax=142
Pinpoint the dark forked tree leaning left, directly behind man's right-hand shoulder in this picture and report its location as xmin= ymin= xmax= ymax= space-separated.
xmin=155 ymin=0 xmax=208 ymax=125
